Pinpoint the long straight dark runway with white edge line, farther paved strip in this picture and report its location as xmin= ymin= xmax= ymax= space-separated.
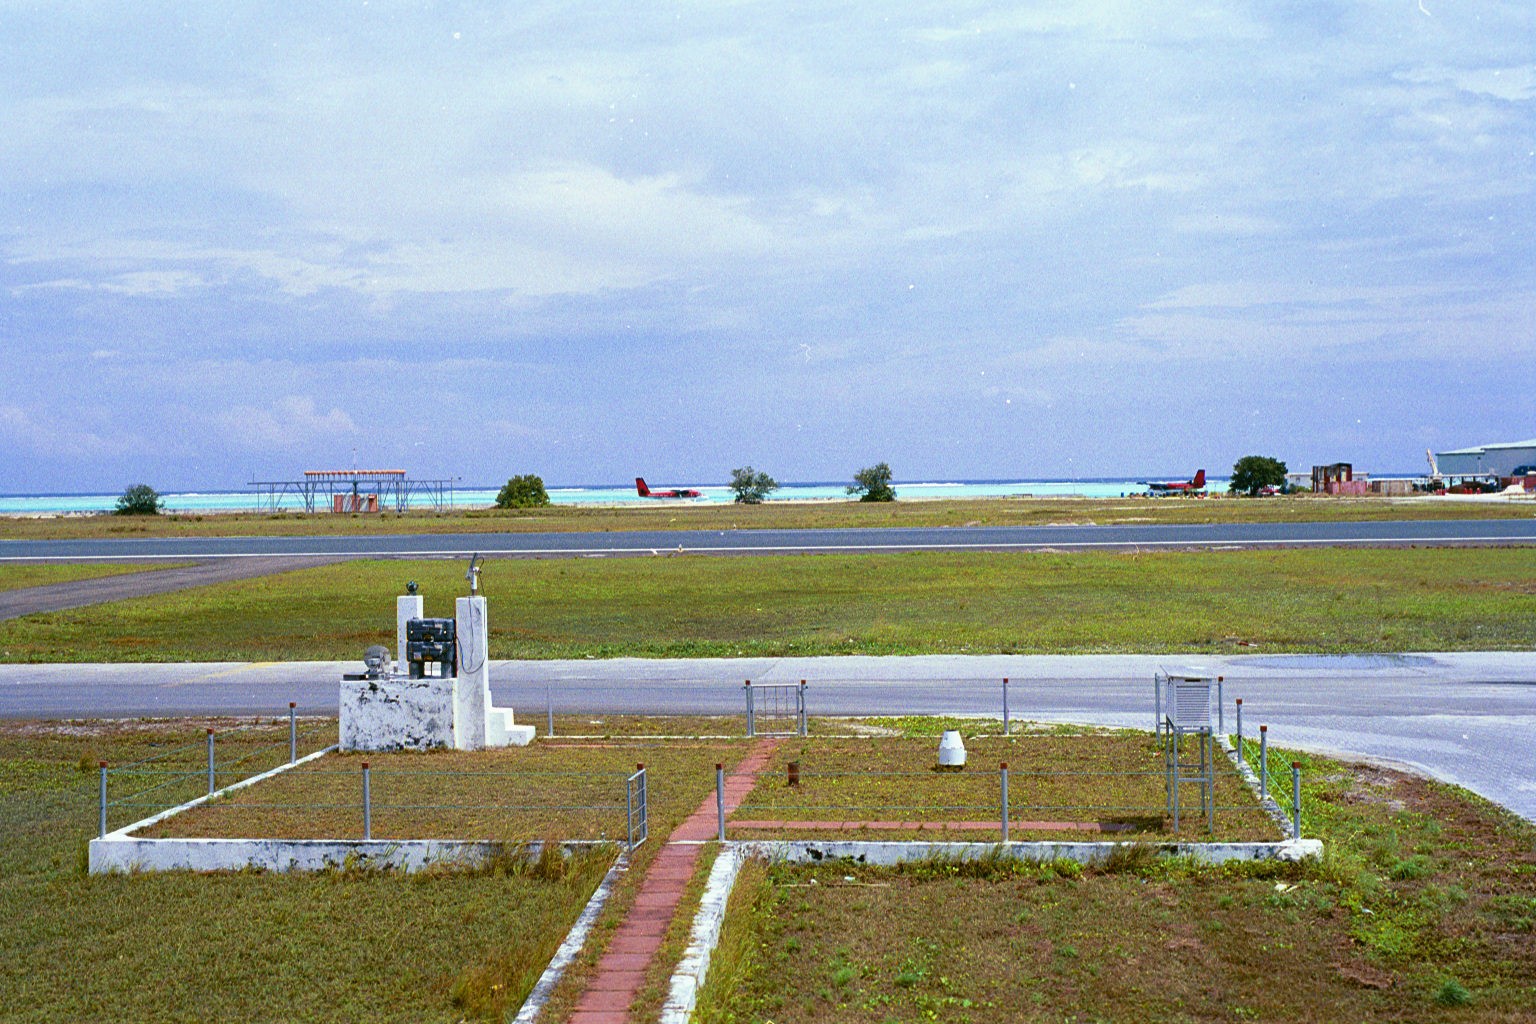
xmin=9 ymin=517 xmax=1536 ymax=562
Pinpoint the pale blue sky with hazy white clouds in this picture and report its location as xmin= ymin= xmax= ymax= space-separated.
xmin=0 ymin=0 xmax=1536 ymax=493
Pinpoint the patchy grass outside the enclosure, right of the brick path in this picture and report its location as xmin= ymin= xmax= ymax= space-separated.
xmin=697 ymin=751 xmax=1536 ymax=1024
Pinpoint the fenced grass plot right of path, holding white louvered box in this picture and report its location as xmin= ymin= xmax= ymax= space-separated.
xmin=728 ymin=732 xmax=1279 ymax=843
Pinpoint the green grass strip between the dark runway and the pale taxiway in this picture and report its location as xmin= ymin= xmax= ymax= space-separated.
xmin=0 ymin=548 xmax=1536 ymax=662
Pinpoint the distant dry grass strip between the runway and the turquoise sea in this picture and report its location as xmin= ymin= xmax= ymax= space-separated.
xmin=0 ymin=496 xmax=1536 ymax=539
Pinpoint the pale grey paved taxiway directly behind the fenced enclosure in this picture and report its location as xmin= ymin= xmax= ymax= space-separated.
xmin=0 ymin=654 xmax=1536 ymax=820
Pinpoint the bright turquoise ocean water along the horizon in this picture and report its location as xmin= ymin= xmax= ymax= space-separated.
xmin=0 ymin=477 xmax=1226 ymax=516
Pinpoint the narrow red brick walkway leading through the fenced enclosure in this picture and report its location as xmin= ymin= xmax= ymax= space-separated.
xmin=570 ymin=740 xmax=779 ymax=1024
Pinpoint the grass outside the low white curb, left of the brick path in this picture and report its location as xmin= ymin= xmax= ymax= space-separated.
xmin=0 ymin=722 xmax=623 ymax=1024
